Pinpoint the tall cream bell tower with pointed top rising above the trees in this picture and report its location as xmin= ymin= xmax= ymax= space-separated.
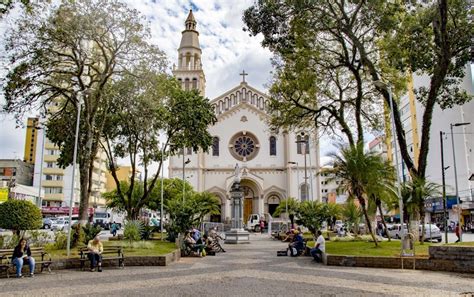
xmin=173 ymin=10 xmax=206 ymax=96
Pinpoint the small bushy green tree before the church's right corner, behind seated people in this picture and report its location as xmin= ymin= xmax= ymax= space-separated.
xmin=297 ymin=201 xmax=332 ymax=238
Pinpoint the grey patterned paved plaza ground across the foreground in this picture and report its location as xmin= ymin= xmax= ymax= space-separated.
xmin=0 ymin=235 xmax=474 ymax=297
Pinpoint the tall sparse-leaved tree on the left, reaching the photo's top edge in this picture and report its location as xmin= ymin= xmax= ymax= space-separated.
xmin=2 ymin=0 xmax=166 ymax=223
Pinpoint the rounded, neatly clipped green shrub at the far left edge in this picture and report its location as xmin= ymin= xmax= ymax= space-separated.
xmin=0 ymin=199 xmax=43 ymax=231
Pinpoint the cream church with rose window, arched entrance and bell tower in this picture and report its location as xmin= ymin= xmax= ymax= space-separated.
xmin=169 ymin=11 xmax=321 ymax=222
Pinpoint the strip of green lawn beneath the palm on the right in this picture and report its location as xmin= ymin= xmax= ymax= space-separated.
xmin=308 ymin=241 xmax=432 ymax=257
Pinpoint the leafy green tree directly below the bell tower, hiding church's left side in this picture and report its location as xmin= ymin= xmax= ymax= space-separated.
xmin=102 ymin=65 xmax=216 ymax=217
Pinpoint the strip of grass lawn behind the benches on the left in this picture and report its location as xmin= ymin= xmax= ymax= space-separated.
xmin=47 ymin=240 xmax=176 ymax=260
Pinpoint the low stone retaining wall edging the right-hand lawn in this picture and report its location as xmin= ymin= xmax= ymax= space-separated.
xmin=325 ymin=246 xmax=474 ymax=273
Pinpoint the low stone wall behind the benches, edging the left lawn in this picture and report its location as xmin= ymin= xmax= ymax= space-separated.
xmin=51 ymin=250 xmax=181 ymax=270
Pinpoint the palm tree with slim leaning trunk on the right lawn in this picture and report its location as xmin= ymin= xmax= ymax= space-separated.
xmin=330 ymin=144 xmax=392 ymax=246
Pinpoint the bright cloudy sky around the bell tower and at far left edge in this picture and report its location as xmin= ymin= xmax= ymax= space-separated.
xmin=0 ymin=0 xmax=334 ymax=166
